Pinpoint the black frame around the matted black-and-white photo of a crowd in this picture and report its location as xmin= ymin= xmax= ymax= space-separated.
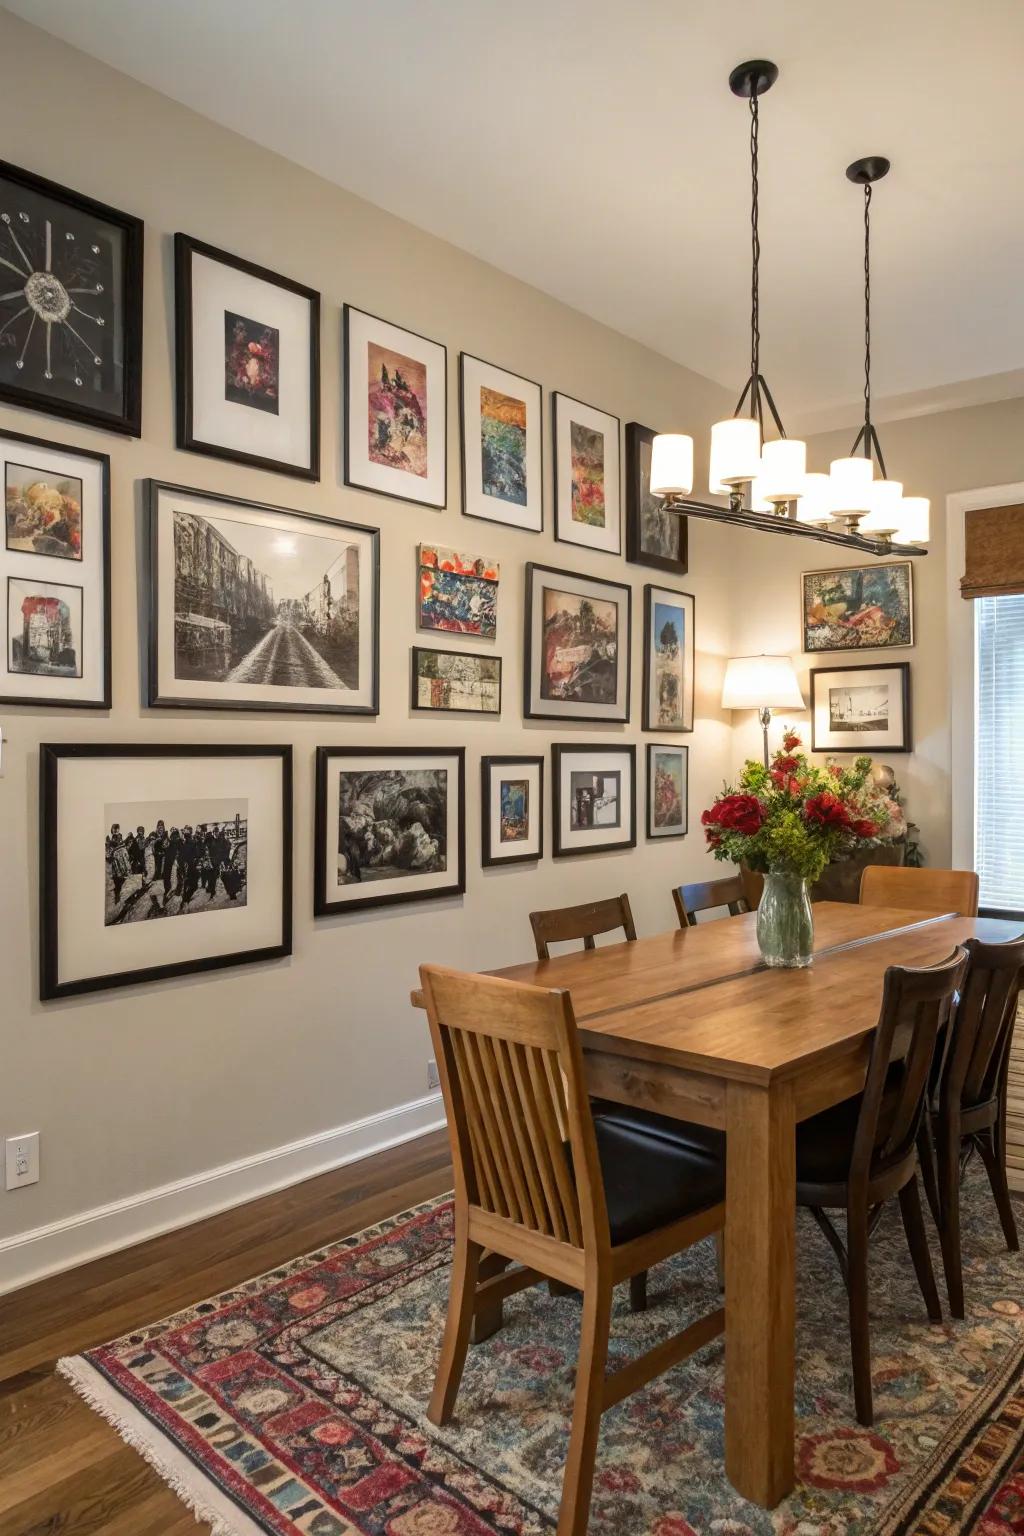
xmin=38 ymin=742 xmax=292 ymax=1001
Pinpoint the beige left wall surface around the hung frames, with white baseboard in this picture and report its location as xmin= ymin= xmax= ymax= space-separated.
xmin=0 ymin=11 xmax=739 ymax=1289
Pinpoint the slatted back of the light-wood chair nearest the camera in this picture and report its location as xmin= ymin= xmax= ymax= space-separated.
xmin=419 ymin=965 xmax=609 ymax=1247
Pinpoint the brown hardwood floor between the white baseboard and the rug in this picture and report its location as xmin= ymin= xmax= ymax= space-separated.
xmin=0 ymin=1130 xmax=451 ymax=1536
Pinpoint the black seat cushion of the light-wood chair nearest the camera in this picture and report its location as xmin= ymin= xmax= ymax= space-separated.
xmin=567 ymin=1120 xmax=725 ymax=1246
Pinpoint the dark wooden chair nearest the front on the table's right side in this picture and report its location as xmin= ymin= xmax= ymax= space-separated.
xmin=797 ymin=948 xmax=967 ymax=1424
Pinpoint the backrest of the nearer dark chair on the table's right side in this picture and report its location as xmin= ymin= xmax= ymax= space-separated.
xmin=849 ymin=946 xmax=967 ymax=1187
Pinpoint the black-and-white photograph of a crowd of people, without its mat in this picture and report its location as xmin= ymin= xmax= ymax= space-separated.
xmin=103 ymin=799 xmax=249 ymax=928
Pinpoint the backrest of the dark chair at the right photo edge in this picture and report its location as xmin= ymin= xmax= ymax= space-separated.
xmin=940 ymin=935 xmax=1024 ymax=1109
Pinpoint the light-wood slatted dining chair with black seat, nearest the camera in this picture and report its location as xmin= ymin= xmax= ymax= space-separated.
xmin=419 ymin=965 xmax=725 ymax=1536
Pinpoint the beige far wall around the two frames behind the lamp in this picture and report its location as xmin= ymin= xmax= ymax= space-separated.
xmin=732 ymin=399 xmax=1024 ymax=865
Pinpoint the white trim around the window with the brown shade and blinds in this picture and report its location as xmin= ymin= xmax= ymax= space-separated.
xmin=946 ymin=481 xmax=1024 ymax=869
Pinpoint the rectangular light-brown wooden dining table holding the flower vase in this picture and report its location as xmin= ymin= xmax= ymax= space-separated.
xmin=411 ymin=902 xmax=1021 ymax=1508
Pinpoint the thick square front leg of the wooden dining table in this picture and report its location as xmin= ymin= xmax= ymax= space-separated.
xmin=725 ymin=1081 xmax=797 ymax=1508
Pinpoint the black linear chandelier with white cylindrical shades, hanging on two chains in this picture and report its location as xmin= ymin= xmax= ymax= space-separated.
xmin=651 ymin=58 xmax=929 ymax=554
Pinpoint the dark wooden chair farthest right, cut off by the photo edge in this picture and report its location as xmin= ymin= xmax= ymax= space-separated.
xmin=918 ymin=935 xmax=1024 ymax=1318
